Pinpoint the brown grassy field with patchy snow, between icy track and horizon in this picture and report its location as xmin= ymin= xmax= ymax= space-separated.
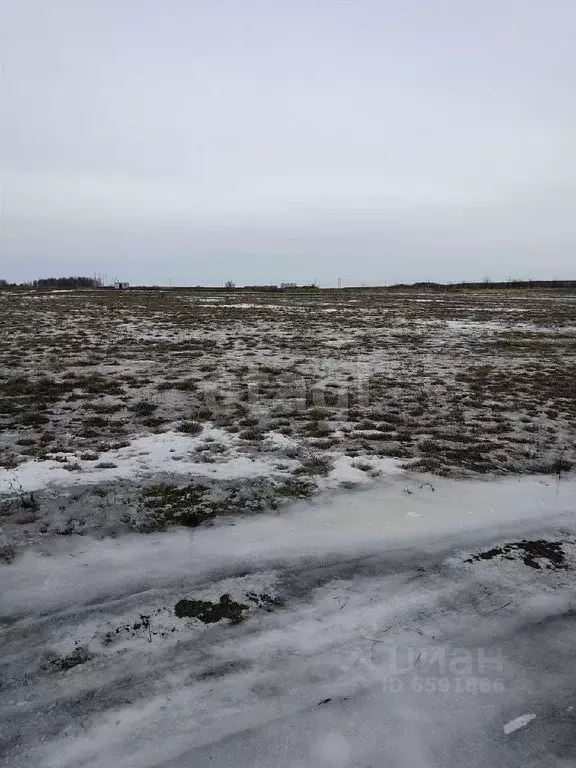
xmin=0 ymin=289 xmax=576 ymax=559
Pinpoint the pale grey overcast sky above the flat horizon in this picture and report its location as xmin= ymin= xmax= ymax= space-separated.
xmin=0 ymin=0 xmax=576 ymax=285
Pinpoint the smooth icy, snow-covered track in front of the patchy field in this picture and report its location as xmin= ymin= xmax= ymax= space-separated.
xmin=0 ymin=472 xmax=576 ymax=768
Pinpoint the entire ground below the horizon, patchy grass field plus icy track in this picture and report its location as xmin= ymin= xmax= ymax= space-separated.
xmin=0 ymin=289 xmax=576 ymax=768
